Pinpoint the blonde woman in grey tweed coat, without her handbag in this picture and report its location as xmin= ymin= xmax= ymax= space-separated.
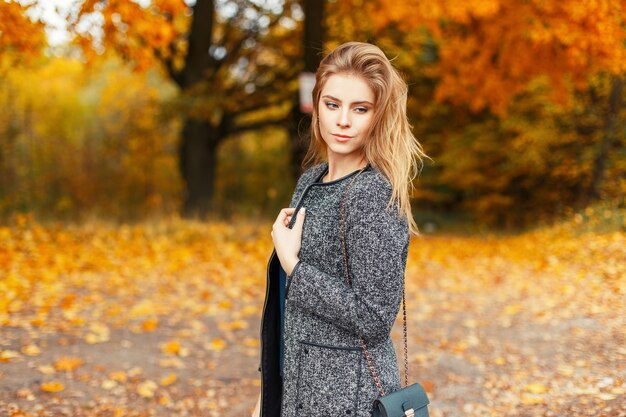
xmin=253 ymin=42 xmax=426 ymax=417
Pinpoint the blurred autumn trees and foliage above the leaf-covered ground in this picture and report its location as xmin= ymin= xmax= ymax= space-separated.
xmin=0 ymin=0 xmax=626 ymax=228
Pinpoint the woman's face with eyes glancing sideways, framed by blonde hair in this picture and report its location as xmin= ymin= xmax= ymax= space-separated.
xmin=318 ymin=74 xmax=374 ymax=160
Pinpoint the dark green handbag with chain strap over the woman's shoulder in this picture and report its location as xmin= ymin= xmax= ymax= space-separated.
xmin=341 ymin=169 xmax=430 ymax=417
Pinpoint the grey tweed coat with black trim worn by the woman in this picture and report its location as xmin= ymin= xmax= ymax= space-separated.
xmin=259 ymin=162 xmax=410 ymax=417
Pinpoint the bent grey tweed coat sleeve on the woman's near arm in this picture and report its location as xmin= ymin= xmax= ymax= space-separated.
xmin=285 ymin=179 xmax=410 ymax=344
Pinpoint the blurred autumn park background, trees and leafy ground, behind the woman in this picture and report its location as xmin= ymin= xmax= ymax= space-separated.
xmin=0 ymin=0 xmax=626 ymax=417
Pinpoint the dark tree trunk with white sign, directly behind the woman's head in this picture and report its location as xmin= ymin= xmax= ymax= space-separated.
xmin=287 ymin=0 xmax=324 ymax=178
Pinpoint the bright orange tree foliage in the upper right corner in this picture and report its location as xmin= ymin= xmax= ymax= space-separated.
xmin=372 ymin=0 xmax=626 ymax=116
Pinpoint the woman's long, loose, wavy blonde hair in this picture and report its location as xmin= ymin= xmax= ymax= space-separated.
xmin=303 ymin=42 xmax=430 ymax=235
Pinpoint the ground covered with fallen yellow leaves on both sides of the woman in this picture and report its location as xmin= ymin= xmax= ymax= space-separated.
xmin=0 ymin=217 xmax=626 ymax=417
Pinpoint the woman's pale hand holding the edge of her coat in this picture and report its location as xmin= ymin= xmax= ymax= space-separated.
xmin=272 ymin=207 xmax=305 ymax=275
